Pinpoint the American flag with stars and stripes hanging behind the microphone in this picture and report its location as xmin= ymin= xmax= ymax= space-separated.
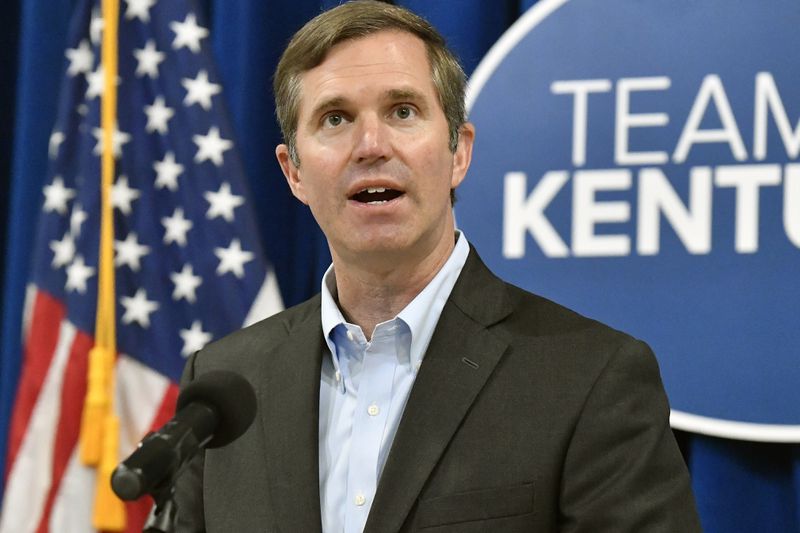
xmin=0 ymin=0 xmax=282 ymax=533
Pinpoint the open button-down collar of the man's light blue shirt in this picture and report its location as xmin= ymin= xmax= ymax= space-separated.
xmin=321 ymin=231 xmax=469 ymax=372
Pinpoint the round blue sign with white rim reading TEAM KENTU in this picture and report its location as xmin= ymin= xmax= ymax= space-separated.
xmin=457 ymin=0 xmax=800 ymax=442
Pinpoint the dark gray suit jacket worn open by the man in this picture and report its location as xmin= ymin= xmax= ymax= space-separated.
xmin=177 ymin=249 xmax=700 ymax=533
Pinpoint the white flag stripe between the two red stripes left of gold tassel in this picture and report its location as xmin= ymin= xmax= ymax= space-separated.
xmin=0 ymin=321 xmax=77 ymax=533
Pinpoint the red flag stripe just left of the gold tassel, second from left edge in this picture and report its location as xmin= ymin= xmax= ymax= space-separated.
xmin=37 ymin=331 xmax=94 ymax=533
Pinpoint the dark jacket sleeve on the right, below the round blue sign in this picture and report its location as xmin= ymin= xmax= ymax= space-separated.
xmin=560 ymin=340 xmax=701 ymax=533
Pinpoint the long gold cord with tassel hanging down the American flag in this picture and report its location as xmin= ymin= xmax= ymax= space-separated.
xmin=74 ymin=0 xmax=126 ymax=531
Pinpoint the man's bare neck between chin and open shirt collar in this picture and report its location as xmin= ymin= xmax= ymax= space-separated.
xmin=334 ymin=233 xmax=454 ymax=338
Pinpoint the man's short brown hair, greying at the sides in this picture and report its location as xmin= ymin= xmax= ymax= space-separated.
xmin=273 ymin=0 xmax=466 ymax=165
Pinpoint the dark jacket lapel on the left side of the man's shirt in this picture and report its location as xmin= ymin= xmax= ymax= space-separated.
xmin=261 ymin=298 xmax=326 ymax=533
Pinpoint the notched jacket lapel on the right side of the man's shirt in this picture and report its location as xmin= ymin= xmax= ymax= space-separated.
xmin=365 ymin=249 xmax=511 ymax=533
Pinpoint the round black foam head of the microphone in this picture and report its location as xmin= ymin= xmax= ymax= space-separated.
xmin=176 ymin=370 xmax=256 ymax=448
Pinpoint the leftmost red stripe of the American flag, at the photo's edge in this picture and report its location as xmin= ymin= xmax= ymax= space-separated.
xmin=5 ymin=290 xmax=65 ymax=483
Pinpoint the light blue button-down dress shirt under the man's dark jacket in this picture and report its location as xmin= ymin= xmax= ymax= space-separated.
xmin=319 ymin=233 xmax=469 ymax=533
